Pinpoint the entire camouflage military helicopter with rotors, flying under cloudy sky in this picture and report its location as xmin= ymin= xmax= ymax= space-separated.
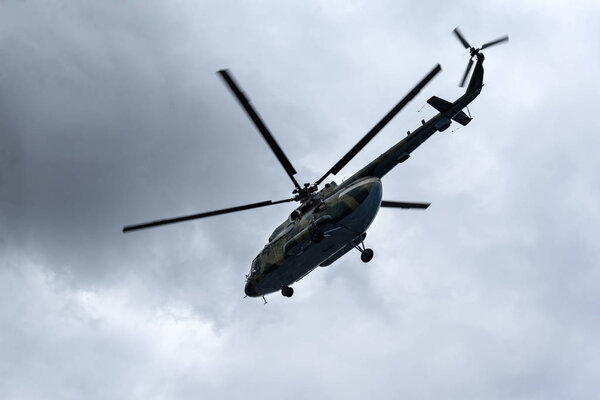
xmin=123 ymin=28 xmax=508 ymax=303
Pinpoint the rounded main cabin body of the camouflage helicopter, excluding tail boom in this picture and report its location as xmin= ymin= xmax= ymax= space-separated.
xmin=245 ymin=177 xmax=382 ymax=297
